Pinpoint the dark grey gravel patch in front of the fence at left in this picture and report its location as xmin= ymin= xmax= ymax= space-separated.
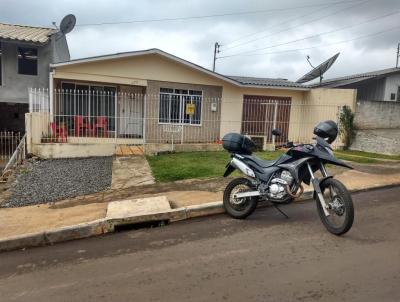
xmin=1 ymin=157 xmax=112 ymax=207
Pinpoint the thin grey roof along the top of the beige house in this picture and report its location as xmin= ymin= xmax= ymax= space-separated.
xmin=50 ymin=48 xmax=310 ymax=90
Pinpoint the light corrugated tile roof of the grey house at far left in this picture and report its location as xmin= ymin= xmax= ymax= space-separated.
xmin=0 ymin=23 xmax=57 ymax=43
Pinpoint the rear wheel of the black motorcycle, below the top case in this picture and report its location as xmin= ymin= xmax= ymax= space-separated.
xmin=224 ymin=178 xmax=257 ymax=219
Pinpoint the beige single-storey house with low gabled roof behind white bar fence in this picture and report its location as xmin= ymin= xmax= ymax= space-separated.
xmin=28 ymin=49 xmax=355 ymax=156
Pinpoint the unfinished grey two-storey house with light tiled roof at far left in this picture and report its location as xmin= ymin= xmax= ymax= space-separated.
xmin=0 ymin=23 xmax=70 ymax=132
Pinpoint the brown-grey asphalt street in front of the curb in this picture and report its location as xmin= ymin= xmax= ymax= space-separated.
xmin=0 ymin=187 xmax=400 ymax=302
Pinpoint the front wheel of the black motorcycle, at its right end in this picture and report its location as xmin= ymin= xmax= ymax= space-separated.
xmin=316 ymin=178 xmax=354 ymax=236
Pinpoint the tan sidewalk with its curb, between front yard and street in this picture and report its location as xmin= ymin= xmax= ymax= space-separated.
xmin=0 ymin=165 xmax=400 ymax=250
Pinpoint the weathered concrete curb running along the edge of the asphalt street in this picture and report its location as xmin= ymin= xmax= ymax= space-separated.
xmin=0 ymin=184 xmax=400 ymax=252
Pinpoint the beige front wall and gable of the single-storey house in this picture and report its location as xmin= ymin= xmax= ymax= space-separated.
xmin=50 ymin=54 xmax=356 ymax=148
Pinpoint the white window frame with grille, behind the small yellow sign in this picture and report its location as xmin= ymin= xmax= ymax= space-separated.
xmin=158 ymin=87 xmax=204 ymax=127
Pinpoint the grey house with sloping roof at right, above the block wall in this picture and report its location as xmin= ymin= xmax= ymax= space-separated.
xmin=313 ymin=68 xmax=400 ymax=102
